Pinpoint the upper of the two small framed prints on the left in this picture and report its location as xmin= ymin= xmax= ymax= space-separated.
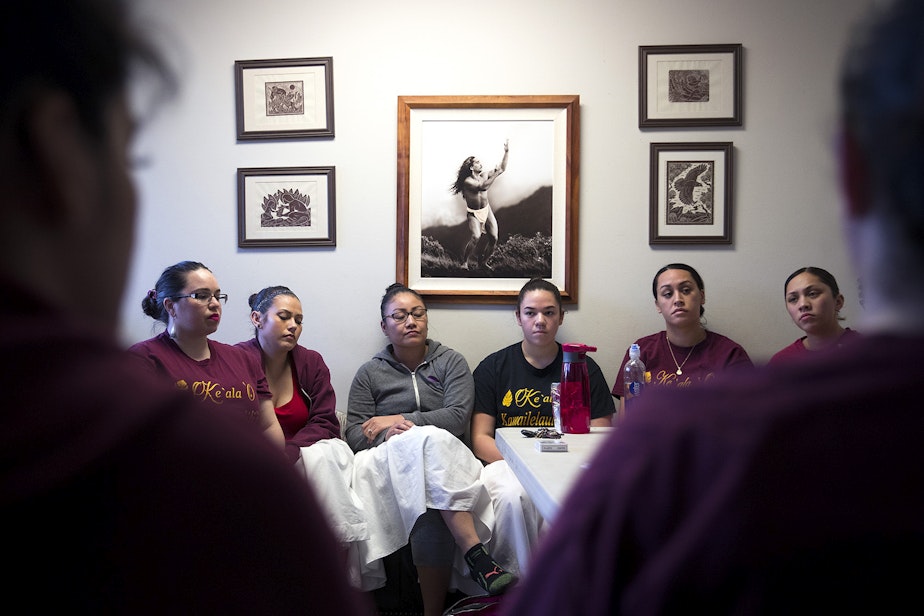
xmin=234 ymin=57 xmax=334 ymax=140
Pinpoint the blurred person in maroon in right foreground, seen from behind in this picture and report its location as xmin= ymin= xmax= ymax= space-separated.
xmin=504 ymin=0 xmax=924 ymax=616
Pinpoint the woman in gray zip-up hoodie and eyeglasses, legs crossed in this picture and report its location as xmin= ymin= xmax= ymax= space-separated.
xmin=344 ymin=284 xmax=515 ymax=614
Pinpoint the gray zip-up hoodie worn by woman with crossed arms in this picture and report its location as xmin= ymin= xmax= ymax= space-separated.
xmin=344 ymin=338 xmax=475 ymax=451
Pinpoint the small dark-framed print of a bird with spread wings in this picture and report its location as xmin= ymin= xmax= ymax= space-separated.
xmin=648 ymin=142 xmax=734 ymax=244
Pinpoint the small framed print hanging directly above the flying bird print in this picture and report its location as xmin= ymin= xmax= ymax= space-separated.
xmin=638 ymin=43 xmax=742 ymax=128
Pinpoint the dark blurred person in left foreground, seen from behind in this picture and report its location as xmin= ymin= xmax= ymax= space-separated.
xmin=0 ymin=0 xmax=367 ymax=614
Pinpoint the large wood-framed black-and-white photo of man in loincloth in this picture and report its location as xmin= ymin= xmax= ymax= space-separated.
xmin=396 ymin=95 xmax=580 ymax=304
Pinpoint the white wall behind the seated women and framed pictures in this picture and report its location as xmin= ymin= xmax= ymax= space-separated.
xmin=121 ymin=0 xmax=871 ymax=408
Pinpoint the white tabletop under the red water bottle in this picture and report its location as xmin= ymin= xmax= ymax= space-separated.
xmin=494 ymin=426 xmax=613 ymax=522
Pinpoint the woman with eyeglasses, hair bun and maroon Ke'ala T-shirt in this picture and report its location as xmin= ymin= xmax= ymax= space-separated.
xmin=129 ymin=261 xmax=285 ymax=449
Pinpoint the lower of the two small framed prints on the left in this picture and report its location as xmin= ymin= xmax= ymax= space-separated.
xmin=237 ymin=167 xmax=337 ymax=248
